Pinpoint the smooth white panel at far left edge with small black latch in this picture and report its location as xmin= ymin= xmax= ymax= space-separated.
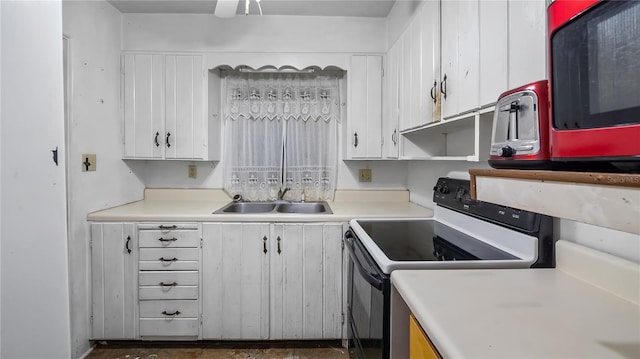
xmin=0 ymin=1 xmax=71 ymax=359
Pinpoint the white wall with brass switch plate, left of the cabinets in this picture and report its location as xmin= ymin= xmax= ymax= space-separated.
xmin=62 ymin=1 xmax=144 ymax=358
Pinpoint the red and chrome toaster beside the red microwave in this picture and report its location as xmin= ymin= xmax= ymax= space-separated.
xmin=489 ymin=80 xmax=552 ymax=169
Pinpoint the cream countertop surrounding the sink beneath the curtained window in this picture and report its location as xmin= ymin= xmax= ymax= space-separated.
xmin=87 ymin=189 xmax=433 ymax=222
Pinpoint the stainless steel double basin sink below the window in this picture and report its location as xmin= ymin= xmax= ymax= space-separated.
xmin=213 ymin=202 xmax=333 ymax=214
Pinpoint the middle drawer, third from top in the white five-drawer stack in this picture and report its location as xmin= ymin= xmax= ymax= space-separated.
xmin=139 ymin=248 xmax=200 ymax=271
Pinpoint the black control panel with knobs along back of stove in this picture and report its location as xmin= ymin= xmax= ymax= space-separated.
xmin=433 ymin=177 xmax=542 ymax=233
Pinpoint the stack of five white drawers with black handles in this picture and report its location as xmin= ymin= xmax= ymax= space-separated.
xmin=138 ymin=223 xmax=202 ymax=339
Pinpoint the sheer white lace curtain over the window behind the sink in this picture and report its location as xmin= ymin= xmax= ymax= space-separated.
xmin=223 ymin=72 xmax=340 ymax=201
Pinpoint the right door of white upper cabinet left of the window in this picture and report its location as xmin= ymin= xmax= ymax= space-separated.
xmin=164 ymin=55 xmax=207 ymax=159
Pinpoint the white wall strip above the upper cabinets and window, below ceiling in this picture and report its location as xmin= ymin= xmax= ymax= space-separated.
xmin=123 ymin=14 xmax=387 ymax=53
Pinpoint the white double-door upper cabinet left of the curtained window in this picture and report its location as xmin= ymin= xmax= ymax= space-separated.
xmin=123 ymin=53 xmax=217 ymax=160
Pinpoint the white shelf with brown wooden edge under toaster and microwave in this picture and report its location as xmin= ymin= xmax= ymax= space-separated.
xmin=469 ymin=169 xmax=640 ymax=234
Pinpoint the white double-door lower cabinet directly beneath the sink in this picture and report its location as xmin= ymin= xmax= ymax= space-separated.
xmin=202 ymin=223 xmax=343 ymax=340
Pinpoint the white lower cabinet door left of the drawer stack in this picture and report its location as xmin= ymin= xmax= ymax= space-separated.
xmin=91 ymin=223 xmax=138 ymax=339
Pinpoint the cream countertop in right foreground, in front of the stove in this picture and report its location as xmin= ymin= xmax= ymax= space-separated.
xmin=391 ymin=241 xmax=640 ymax=358
